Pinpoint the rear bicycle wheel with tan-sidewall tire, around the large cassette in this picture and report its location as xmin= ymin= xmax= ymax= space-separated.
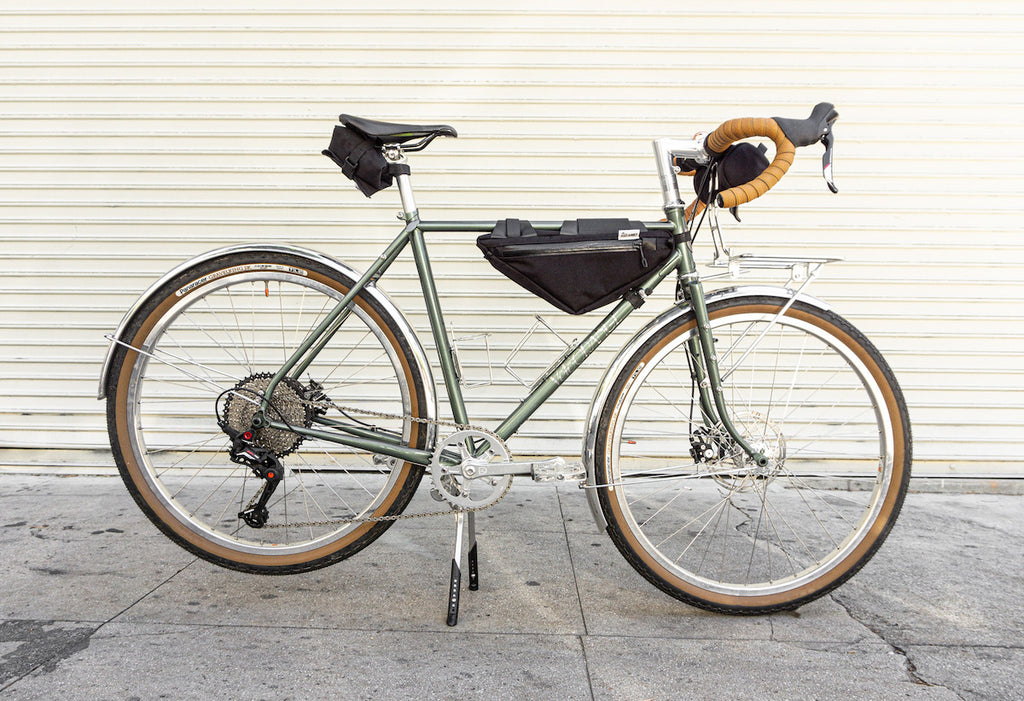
xmin=106 ymin=251 xmax=429 ymax=574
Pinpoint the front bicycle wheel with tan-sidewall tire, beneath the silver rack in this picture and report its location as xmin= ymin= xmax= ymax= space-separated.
xmin=595 ymin=297 xmax=911 ymax=613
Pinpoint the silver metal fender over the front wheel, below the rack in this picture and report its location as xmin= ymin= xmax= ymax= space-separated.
xmin=583 ymin=284 xmax=829 ymax=531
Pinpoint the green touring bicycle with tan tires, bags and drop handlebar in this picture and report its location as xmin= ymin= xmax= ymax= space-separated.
xmin=99 ymin=103 xmax=911 ymax=625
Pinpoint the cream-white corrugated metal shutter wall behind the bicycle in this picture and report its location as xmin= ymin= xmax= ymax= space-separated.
xmin=0 ymin=0 xmax=1024 ymax=475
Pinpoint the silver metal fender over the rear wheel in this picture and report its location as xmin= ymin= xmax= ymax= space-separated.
xmin=96 ymin=244 xmax=437 ymax=431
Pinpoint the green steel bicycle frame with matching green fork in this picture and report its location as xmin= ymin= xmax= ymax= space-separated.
xmin=253 ymin=207 xmax=766 ymax=465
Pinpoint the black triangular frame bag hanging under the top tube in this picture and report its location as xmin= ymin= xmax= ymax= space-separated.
xmin=476 ymin=219 xmax=673 ymax=314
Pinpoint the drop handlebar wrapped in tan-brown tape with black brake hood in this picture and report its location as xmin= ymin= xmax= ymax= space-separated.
xmin=705 ymin=102 xmax=839 ymax=209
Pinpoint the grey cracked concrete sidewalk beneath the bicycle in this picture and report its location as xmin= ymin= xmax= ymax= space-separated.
xmin=0 ymin=475 xmax=1024 ymax=700
